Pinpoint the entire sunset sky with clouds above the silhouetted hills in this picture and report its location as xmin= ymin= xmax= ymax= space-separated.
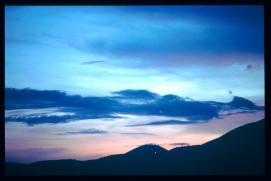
xmin=5 ymin=6 xmax=264 ymax=162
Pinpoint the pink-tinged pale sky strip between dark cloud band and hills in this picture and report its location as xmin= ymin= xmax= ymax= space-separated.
xmin=5 ymin=111 xmax=264 ymax=162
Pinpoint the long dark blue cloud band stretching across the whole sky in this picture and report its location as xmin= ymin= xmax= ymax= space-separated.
xmin=5 ymin=88 xmax=264 ymax=125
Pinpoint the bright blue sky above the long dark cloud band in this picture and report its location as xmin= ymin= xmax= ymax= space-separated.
xmin=5 ymin=6 xmax=264 ymax=102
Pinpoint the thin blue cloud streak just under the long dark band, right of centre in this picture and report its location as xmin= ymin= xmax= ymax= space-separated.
xmin=127 ymin=120 xmax=199 ymax=127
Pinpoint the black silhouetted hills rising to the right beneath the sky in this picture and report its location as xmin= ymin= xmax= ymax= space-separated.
xmin=5 ymin=120 xmax=265 ymax=175
